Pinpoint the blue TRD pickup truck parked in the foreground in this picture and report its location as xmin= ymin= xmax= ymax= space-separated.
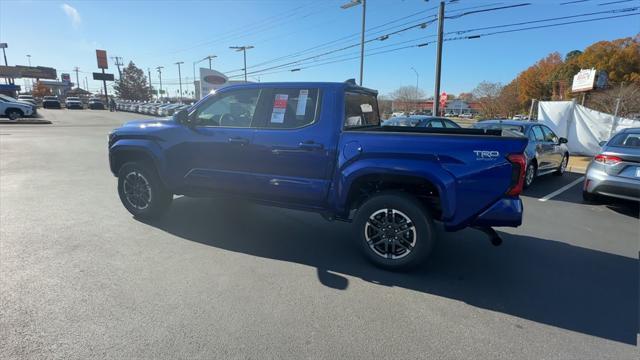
xmin=109 ymin=81 xmax=527 ymax=269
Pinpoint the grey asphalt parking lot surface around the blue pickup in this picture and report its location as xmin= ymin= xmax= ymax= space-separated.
xmin=0 ymin=110 xmax=640 ymax=359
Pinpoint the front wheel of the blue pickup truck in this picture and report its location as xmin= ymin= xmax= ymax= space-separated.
xmin=118 ymin=162 xmax=173 ymax=219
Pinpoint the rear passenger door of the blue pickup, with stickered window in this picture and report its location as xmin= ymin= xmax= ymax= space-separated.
xmin=253 ymin=86 xmax=336 ymax=207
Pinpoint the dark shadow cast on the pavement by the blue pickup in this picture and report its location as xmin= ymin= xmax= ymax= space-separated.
xmin=141 ymin=197 xmax=638 ymax=344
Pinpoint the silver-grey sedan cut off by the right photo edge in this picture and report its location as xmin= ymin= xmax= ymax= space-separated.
xmin=582 ymin=128 xmax=640 ymax=202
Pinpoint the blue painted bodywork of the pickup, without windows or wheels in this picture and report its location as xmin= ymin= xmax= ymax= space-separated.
xmin=109 ymin=83 xmax=527 ymax=230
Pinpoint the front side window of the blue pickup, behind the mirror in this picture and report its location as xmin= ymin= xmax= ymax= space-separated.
xmin=192 ymin=89 xmax=260 ymax=127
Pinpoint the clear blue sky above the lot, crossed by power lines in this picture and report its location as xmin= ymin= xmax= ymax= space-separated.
xmin=0 ymin=0 xmax=640 ymax=96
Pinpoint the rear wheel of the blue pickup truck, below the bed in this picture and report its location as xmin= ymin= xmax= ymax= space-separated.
xmin=354 ymin=191 xmax=435 ymax=270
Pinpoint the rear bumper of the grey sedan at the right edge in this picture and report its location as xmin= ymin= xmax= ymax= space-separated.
xmin=583 ymin=167 xmax=640 ymax=201
